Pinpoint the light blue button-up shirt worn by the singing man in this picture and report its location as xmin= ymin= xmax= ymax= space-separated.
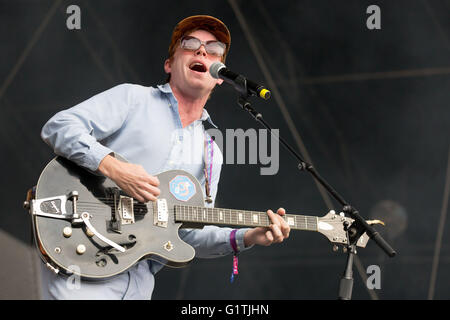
xmin=41 ymin=83 xmax=250 ymax=299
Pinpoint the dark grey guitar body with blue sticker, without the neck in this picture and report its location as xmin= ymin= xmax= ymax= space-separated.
xmin=32 ymin=156 xmax=199 ymax=280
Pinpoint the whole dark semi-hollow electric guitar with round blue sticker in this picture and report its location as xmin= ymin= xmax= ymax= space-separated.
xmin=29 ymin=155 xmax=369 ymax=280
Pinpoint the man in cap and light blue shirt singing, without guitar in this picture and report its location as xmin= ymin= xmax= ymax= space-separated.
xmin=42 ymin=15 xmax=290 ymax=299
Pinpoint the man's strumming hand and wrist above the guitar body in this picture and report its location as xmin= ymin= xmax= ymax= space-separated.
xmin=98 ymin=155 xmax=161 ymax=202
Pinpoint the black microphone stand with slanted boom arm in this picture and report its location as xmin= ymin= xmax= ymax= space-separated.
xmin=234 ymin=76 xmax=397 ymax=300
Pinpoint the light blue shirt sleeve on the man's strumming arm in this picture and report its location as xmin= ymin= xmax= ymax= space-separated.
xmin=41 ymin=84 xmax=133 ymax=171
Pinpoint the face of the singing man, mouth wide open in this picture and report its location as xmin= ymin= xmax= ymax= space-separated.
xmin=164 ymin=30 xmax=223 ymax=97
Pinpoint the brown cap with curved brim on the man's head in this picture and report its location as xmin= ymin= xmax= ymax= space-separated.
xmin=169 ymin=15 xmax=231 ymax=61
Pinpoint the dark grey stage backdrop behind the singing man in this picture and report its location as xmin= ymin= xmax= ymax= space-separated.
xmin=0 ymin=0 xmax=450 ymax=299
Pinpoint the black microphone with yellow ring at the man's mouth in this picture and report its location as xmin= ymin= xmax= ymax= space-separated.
xmin=209 ymin=62 xmax=270 ymax=100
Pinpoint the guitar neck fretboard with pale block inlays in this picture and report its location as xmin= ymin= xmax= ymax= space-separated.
xmin=174 ymin=205 xmax=318 ymax=231
